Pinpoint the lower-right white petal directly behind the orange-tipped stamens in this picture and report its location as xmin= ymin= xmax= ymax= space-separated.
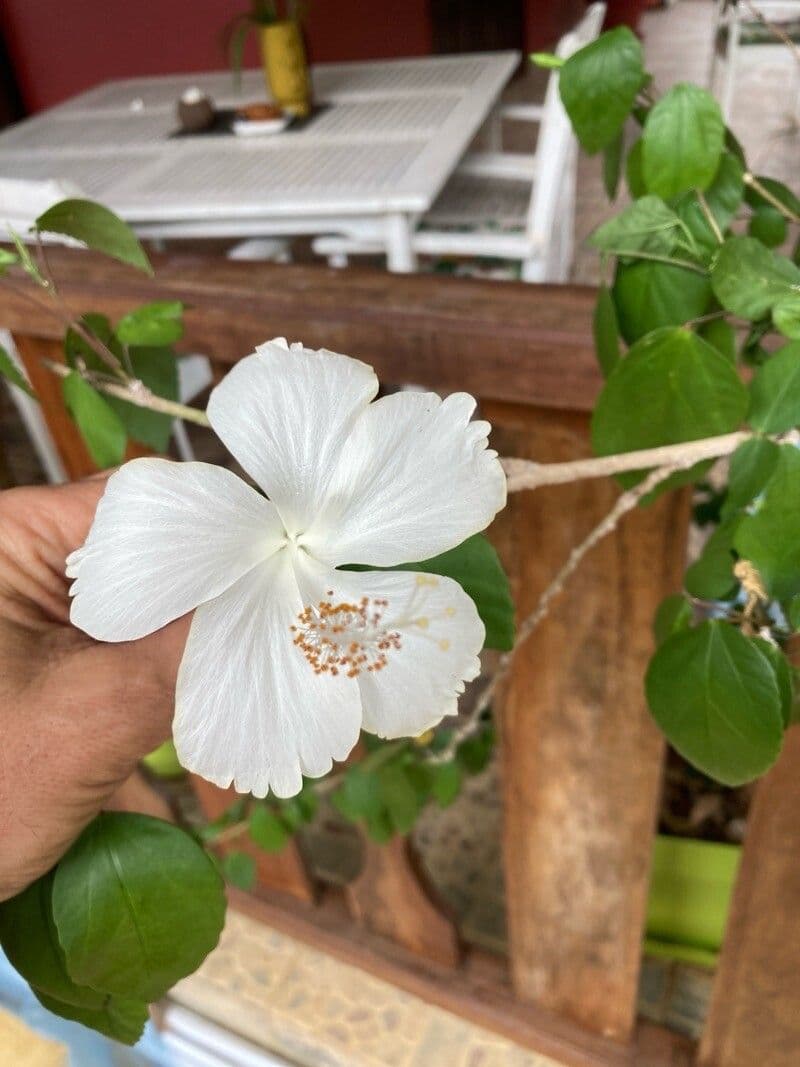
xmin=298 ymin=554 xmax=485 ymax=737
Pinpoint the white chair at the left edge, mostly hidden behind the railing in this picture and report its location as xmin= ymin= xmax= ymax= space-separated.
xmin=0 ymin=178 xmax=212 ymax=482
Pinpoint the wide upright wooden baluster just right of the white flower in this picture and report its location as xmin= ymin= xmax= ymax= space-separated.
xmin=483 ymin=404 xmax=688 ymax=1039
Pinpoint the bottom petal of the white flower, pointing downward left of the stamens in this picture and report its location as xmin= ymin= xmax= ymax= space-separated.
xmin=178 ymin=551 xmax=361 ymax=797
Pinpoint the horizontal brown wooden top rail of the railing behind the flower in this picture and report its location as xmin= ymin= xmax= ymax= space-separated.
xmin=0 ymin=248 xmax=602 ymax=411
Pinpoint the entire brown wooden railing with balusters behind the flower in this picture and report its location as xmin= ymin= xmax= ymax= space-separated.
xmin=0 ymin=251 xmax=800 ymax=1067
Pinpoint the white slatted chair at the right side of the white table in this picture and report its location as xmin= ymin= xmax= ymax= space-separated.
xmin=313 ymin=3 xmax=605 ymax=282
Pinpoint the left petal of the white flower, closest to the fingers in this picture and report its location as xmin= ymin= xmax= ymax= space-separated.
xmin=66 ymin=459 xmax=285 ymax=641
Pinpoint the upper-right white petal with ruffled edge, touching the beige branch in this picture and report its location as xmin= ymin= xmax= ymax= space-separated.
xmin=304 ymin=393 xmax=506 ymax=567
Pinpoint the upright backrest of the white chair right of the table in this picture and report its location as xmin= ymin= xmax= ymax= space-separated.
xmin=527 ymin=3 xmax=606 ymax=256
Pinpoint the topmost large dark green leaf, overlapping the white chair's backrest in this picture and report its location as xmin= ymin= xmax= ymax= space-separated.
xmin=559 ymin=26 xmax=644 ymax=153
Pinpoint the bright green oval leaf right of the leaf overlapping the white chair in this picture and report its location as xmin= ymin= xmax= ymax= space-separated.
xmin=642 ymin=82 xmax=725 ymax=200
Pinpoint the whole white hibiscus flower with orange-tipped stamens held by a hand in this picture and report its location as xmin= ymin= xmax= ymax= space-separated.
xmin=67 ymin=338 xmax=506 ymax=797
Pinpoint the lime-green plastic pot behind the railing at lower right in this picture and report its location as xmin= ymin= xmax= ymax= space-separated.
xmin=644 ymin=835 xmax=741 ymax=967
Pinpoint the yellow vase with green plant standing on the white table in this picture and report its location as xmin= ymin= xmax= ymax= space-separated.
xmin=228 ymin=0 xmax=311 ymax=116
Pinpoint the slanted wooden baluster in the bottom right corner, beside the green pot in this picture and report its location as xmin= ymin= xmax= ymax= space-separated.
xmin=699 ymin=727 xmax=800 ymax=1067
